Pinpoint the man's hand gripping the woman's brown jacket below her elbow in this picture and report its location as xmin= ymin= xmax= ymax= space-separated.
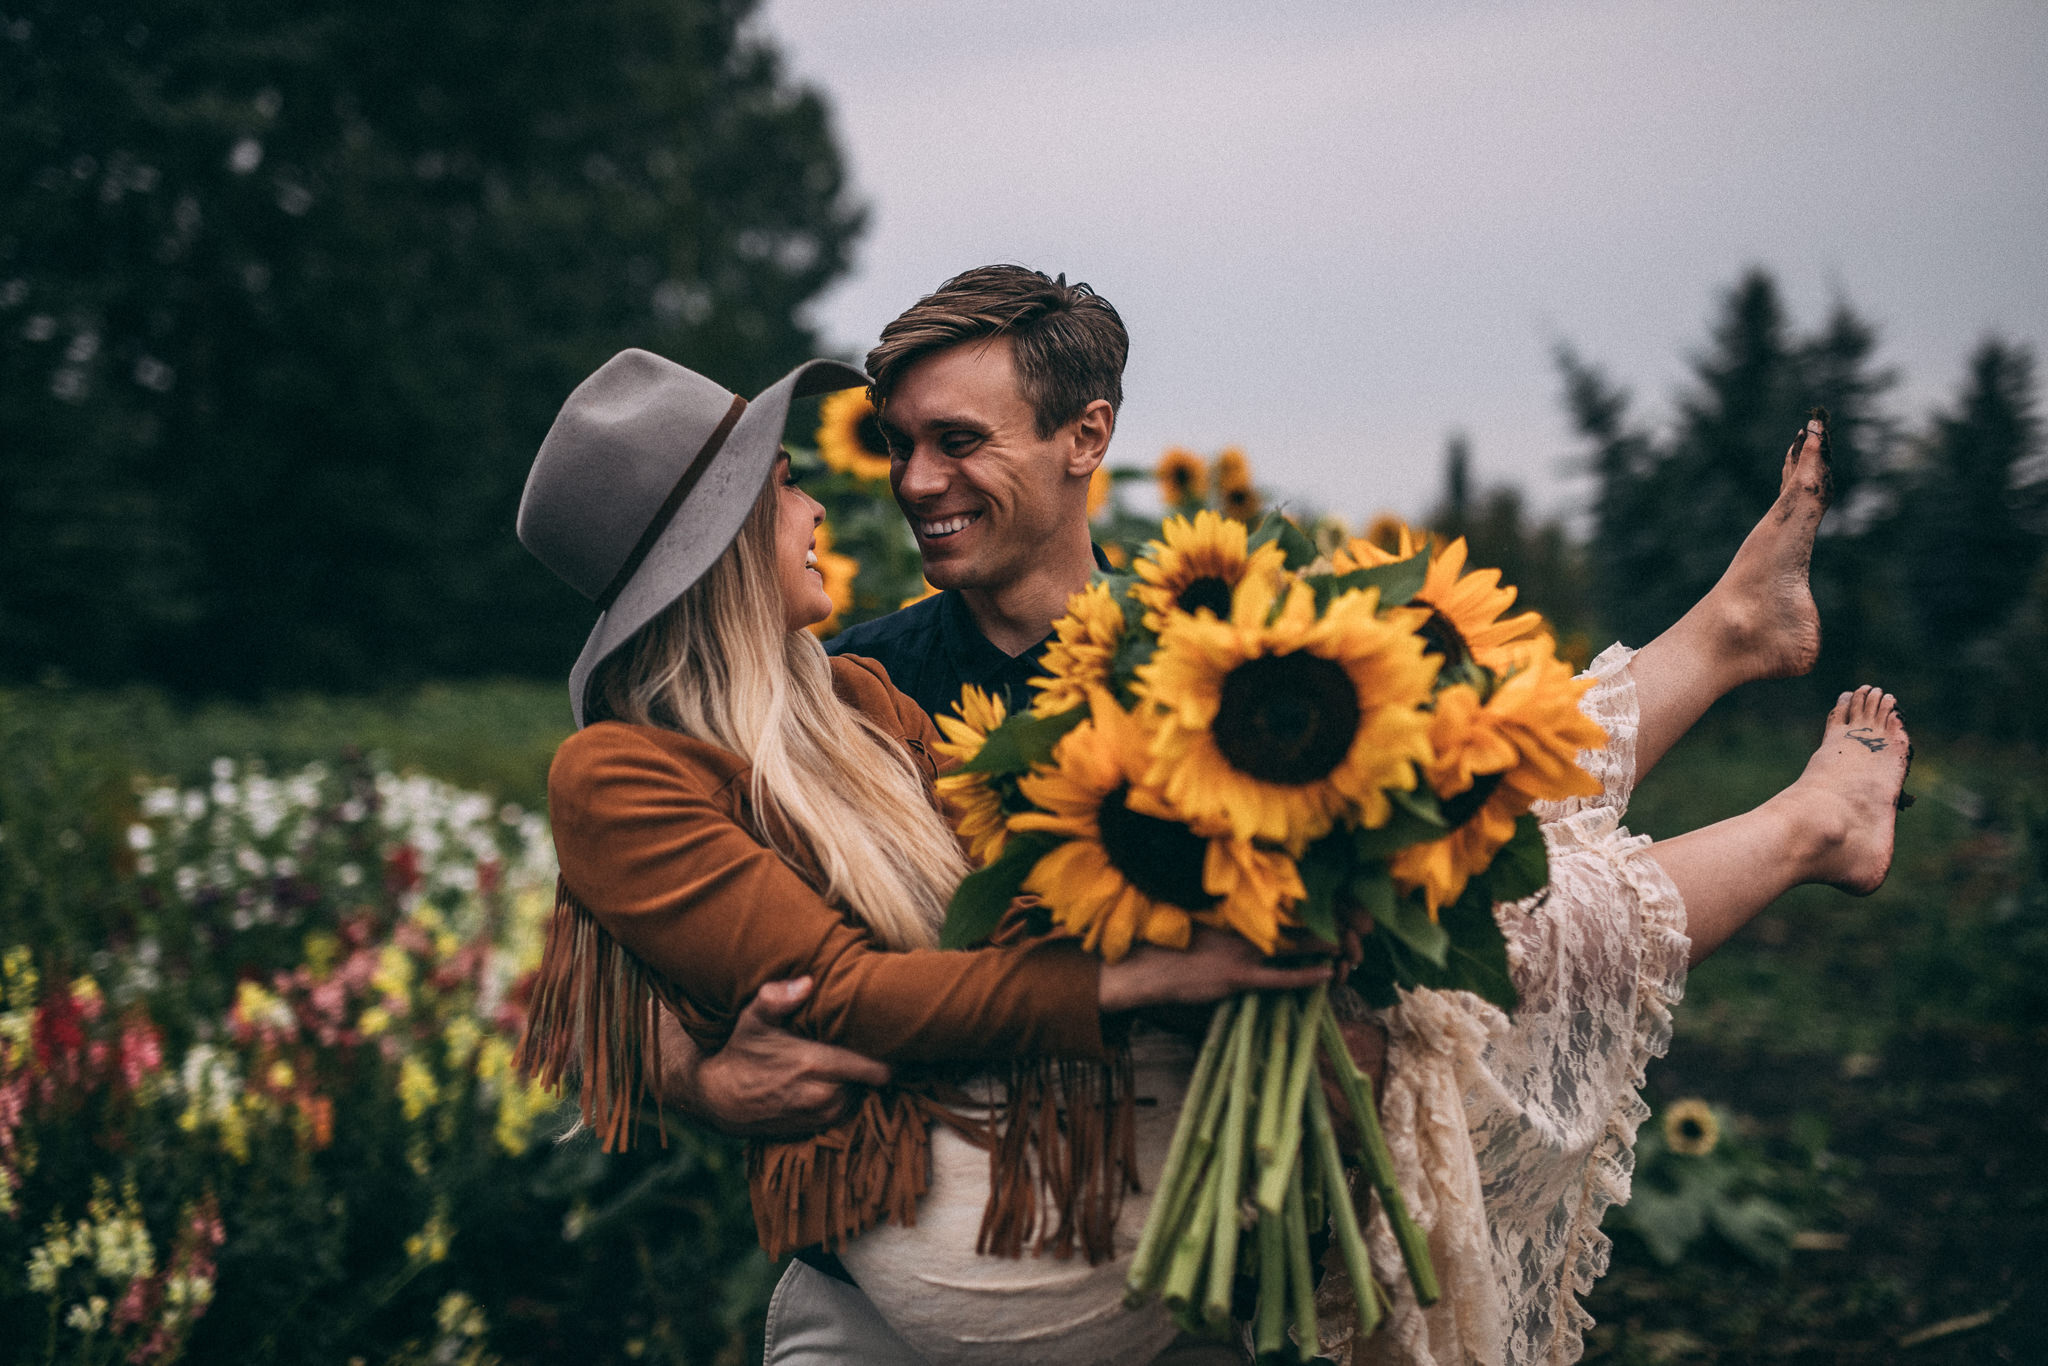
xmin=659 ymin=977 xmax=889 ymax=1139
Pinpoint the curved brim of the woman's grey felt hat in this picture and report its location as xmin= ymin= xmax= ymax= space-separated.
xmin=569 ymin=360 xmax=868 ymax=729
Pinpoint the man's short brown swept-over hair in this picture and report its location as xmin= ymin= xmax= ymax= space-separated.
xmin=868 ymin=266 xmax=1130 ymax=436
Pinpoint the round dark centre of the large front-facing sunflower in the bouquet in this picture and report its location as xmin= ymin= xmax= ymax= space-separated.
xmin=1210 ymin=651 xmax=1358 ymax=784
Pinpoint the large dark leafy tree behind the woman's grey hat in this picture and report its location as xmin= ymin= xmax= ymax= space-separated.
xmin=0 ymin=0 xmax=860 ymax=690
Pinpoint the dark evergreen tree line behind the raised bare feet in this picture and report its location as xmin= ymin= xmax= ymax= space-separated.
xmin=1430 ymin=268 xmax=2048 ymax=741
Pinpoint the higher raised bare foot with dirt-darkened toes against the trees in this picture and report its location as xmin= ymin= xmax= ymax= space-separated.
xmin=1700 ymin=418 xmax=1835 ymax=680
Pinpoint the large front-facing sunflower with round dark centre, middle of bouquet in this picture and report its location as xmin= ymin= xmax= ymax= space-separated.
xmin=1139 ymin=573 xmax=1438 ymax=854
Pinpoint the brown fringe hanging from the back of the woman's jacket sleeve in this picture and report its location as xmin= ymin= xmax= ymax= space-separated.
xmin=512 ymin=879 xmax=668 ymax=1153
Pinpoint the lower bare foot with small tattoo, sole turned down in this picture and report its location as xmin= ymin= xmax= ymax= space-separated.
xmin=1774 ymin=686 xmax=1913 ymax=897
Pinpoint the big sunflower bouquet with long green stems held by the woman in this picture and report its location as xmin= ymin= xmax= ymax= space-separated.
xmin=938 ymin=510 xmax=1606 ymax=1354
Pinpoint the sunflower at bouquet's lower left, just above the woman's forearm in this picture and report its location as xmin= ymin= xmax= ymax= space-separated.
xmin=1010 ymin=692 xmax=1300 ymax=963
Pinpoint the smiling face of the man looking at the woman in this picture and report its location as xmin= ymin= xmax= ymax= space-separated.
xmin=883 ymin=336 xmax=1100 ymax=590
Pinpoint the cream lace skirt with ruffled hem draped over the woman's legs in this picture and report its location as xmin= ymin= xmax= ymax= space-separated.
xmin=1325 ymin=647 xmax=1690 ymax=1366
